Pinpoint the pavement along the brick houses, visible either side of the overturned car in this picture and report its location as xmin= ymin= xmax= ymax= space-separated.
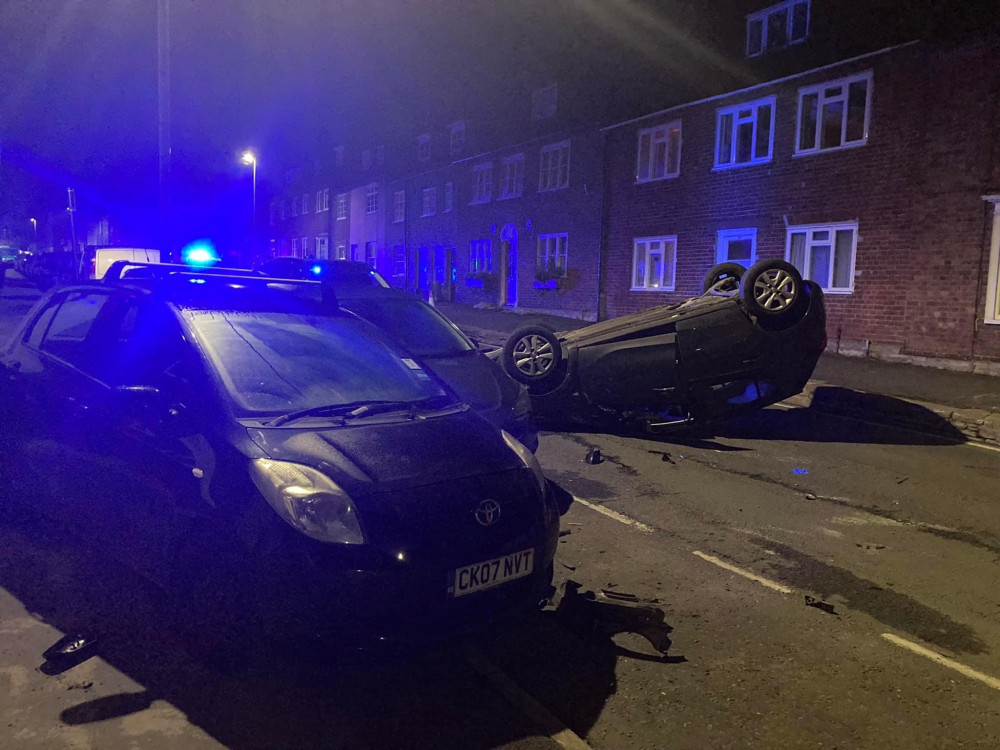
xmin=437 ymin=302 xmax=1000 ymax=445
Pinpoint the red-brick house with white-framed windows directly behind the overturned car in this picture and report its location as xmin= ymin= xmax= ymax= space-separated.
xmin=602 ymin=32 xmax=1000 ymax=369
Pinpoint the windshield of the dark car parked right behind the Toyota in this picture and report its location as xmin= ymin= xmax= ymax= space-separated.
xmin=341 ymin=298 xmax=473 ymax=357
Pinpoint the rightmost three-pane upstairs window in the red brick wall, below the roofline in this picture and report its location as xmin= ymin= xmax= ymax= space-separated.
xmin=795 ymin=70 xmax=872 ymax=154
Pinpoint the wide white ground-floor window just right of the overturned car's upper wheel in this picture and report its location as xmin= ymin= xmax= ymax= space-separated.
xmin=786 ymin=222 xmax=858 ymax=294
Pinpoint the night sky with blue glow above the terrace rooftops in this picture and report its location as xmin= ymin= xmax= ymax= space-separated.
xmin=0 ymin=0 xmax=996 ymax=239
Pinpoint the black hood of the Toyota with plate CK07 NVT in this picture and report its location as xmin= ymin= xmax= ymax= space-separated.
xmin=247 ymin=411 xmax=523 ymax=497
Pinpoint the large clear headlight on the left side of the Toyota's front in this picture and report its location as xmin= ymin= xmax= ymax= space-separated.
xmin=250 ymin=458 xmax=365 ymax=544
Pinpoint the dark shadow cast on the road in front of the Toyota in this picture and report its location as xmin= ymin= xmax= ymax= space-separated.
xmin=0 ymin=478 xmax=679 ymax=749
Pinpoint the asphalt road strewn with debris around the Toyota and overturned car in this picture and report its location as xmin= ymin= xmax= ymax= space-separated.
xmin=0 ymin=280 xmax=1000 ymax=750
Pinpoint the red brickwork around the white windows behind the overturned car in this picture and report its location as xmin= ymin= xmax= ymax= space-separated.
xmin=604 ymin=36 xmax=1000 ymax=366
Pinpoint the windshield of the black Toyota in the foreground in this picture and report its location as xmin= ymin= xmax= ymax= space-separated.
xmin=183 ymin=310 xmax=444 ymax=417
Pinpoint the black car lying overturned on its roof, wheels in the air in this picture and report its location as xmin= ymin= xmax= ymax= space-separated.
xmin=497 ymin=260 xmax=826 ymax=429
